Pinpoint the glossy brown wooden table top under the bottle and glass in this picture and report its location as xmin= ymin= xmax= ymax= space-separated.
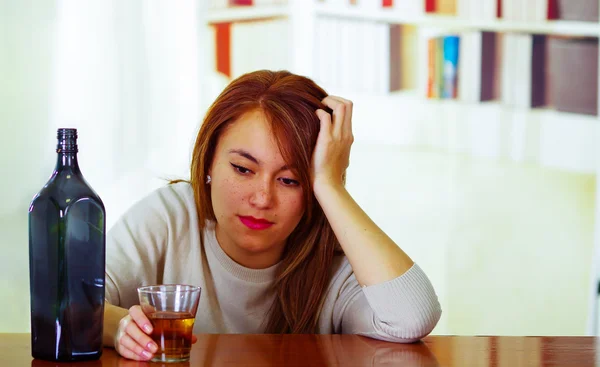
xmin=0 ymin=334 xmax=600 ymax=367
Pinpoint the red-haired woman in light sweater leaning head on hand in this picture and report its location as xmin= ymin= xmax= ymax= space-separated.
xmin=104 ymin=71 xmax=441 ymax=360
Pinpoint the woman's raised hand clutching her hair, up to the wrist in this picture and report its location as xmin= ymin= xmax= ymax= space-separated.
xmin=312 ymin=96 xmax=354 ymax=187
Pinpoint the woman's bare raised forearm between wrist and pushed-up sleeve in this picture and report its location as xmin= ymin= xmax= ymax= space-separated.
xmin=315 ymin=184 xmax=413 ymax=286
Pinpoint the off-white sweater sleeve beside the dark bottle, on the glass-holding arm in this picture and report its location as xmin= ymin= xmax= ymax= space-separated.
xmin=105 ymin=187 xmax=168 ymax=308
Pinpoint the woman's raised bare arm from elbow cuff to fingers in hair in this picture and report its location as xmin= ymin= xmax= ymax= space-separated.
xmin=312 ymin=96 xmax=413 ymax=286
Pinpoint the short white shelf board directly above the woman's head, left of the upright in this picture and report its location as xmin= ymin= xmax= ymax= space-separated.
xmin=206 ymin=5 xmax=290 ymax=24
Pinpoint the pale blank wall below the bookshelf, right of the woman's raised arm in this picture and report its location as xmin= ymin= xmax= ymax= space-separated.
xmin=348 ymin=143 xmax=595 ymax=335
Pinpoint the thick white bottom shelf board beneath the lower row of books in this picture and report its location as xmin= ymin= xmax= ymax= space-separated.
xmin=340 ymin=91 xmax=600 ymax=174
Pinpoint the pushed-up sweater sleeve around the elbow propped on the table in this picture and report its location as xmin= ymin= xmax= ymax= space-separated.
xmin=334 ymin=263 xmax=442 ymax=343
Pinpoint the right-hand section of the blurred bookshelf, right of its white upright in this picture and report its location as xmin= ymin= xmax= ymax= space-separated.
xmin=313 ymin=0 xmax=600 ymax=178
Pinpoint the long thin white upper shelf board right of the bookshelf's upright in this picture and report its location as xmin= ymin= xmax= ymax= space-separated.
xmin=315 ymin=5 xmax=600 ymax=37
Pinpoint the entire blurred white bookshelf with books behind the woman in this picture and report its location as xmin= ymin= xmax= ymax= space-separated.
xmin=199 ymin=0 xmax=600 ymax=332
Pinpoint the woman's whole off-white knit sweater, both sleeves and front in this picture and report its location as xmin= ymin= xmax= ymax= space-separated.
xmin=106 ymin=183 xmax=441 ymax=342
